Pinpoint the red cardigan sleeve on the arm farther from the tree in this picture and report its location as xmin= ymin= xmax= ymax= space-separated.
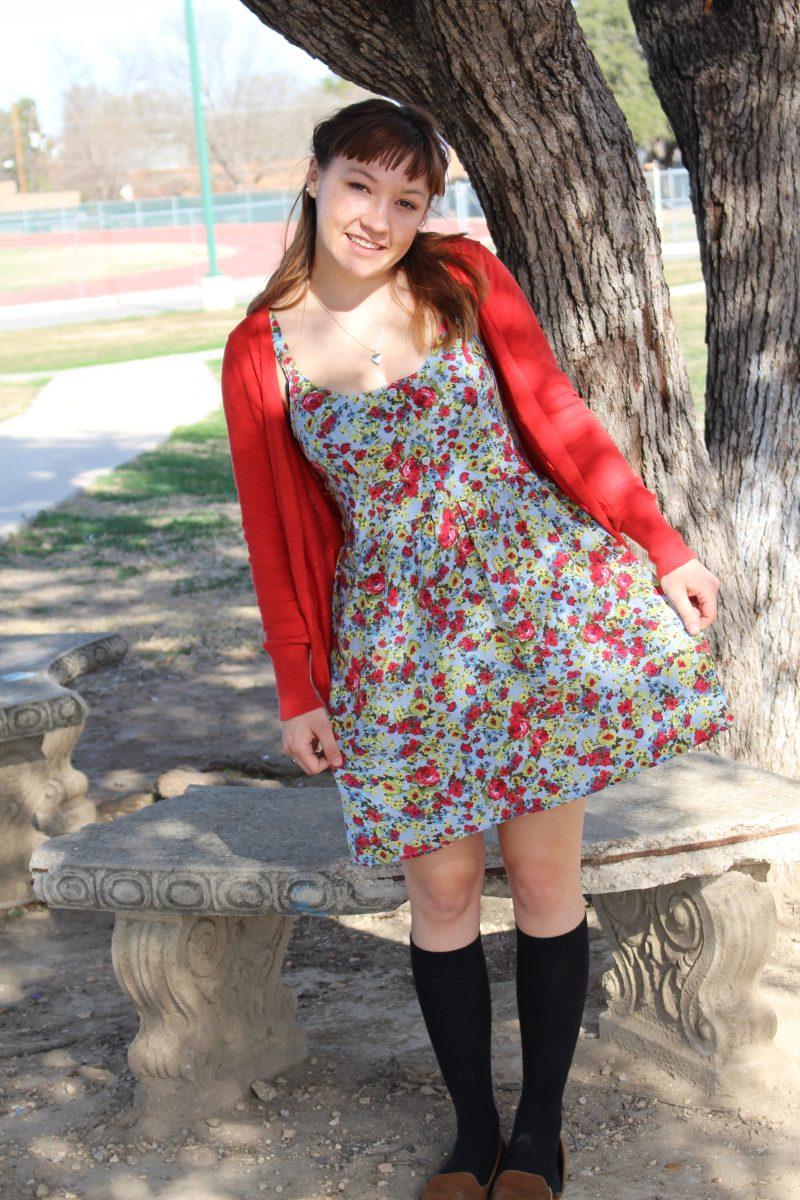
xmin=222 ymin=330 xmax=323 ymax=721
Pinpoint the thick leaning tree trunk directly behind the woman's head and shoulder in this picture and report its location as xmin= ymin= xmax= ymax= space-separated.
xmin=241 ymin=0 xmax=762 ymax=762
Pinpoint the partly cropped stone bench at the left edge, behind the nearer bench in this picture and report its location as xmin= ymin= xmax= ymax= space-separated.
xmin=0 ymin=634 xmax=128 ymax=908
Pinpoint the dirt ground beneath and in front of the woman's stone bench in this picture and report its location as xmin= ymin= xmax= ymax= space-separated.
xmin=0 ymin=898 xmax=800 ymax=1200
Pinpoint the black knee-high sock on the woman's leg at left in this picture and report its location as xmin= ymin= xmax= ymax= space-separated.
xmin=409 ymin=934 xmax=500 ymax=1187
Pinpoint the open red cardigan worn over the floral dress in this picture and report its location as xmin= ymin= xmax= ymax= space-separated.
xmin=222 ymin=238 xmax=697 ymax=721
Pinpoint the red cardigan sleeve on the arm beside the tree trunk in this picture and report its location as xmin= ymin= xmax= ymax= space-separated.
xmin=482 ymin=246 xmax=698 ymax=578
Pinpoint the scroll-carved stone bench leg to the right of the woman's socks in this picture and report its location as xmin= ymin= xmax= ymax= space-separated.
xmin=591 ymin=863 xmax=777 ymax=1088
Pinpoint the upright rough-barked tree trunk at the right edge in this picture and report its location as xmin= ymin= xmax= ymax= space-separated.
xmin=630 ymin=0 xmax=800 ymax=775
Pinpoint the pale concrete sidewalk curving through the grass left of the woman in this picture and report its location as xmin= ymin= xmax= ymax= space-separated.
xmin=0 ymin=350 xmax=222 ymax=538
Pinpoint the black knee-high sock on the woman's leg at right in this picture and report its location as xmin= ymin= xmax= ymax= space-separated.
xmin=501 ymin=912 xmax=589 ymax=1193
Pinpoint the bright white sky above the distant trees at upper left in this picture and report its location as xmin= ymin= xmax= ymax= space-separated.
xmin=0 ymin=0 xmax=329 ymax=134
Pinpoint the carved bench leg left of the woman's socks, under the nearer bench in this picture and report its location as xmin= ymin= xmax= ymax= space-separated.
xmin=112 ymin=912 xmax=307 ymax=1136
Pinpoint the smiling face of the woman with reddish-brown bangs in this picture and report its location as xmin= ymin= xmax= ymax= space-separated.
xmin=306 ymin=155 xmax=429 ymax=278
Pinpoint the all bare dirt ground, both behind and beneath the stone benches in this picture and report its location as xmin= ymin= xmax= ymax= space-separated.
xmin=0 ymin=546 xmax=800 ymax=1200
